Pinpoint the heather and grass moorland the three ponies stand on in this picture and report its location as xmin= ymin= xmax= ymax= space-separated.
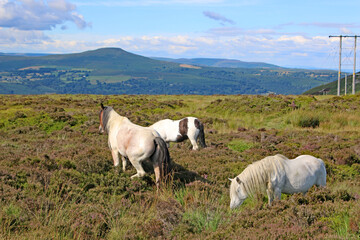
xmin=0 ymin=94 xmax=360 ymax=239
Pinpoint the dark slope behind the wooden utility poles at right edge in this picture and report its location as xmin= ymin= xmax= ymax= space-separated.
xmin=303 ymin=73 xmax=360 ymax=95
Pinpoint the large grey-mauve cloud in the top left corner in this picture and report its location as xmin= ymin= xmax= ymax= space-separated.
xmin=0 ymin=0 xmax=90 ymax=30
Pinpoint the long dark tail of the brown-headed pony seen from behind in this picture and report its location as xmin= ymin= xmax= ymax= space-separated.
xmin=151 ymin=137 xmax=171 ymax=184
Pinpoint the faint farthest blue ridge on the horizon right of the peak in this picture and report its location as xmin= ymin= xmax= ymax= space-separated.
xmin=153 ymin=57 xmax=282 ymax=69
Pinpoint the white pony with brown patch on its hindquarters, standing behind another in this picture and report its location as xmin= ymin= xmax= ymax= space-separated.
xmin=150 ymin=117 xmax=206 ymax=150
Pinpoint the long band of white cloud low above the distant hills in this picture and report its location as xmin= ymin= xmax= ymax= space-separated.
xmin=0 ymin=29 xmax=335 ymax=54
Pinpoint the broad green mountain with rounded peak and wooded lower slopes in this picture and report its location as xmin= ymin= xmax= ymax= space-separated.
xmin=0 ymin=48 xmax=336 ymax=94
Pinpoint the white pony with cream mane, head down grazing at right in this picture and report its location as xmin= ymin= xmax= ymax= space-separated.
xmin=230 ymin=154 xmax=326 ymax=208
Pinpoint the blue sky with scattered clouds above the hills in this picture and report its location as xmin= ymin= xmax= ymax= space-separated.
xmin=0 ymin=0 xmax=360 ymax=69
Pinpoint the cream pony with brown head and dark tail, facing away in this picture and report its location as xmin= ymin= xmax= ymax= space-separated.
xmin=99 ymin=104 xmax=170 ymax=187
